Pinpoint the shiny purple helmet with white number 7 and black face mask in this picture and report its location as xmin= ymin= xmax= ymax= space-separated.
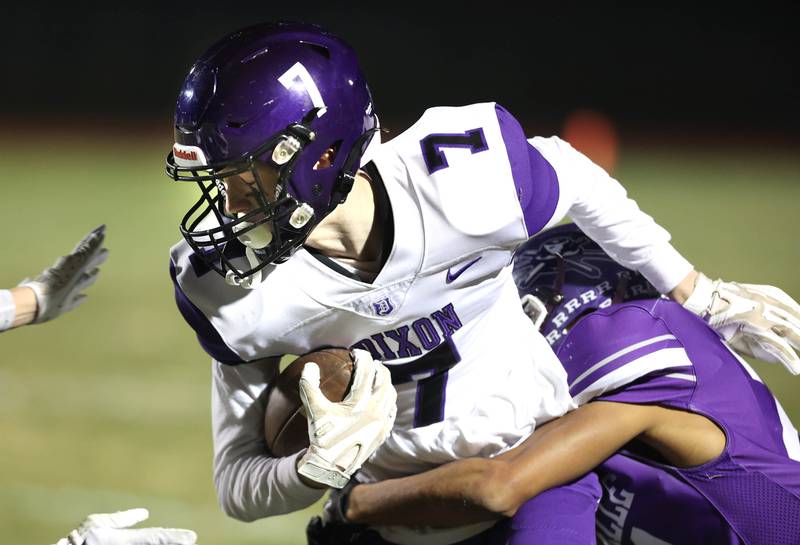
xmin=167 ymin=23 xmax=377 ymax=285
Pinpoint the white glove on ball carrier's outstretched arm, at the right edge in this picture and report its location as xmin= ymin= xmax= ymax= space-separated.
xmin=683 ymin=273 xmax=800 ymax=375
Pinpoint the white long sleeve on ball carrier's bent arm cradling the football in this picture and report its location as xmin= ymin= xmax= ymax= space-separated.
xmin=211 ymin=360 xmax=325 ymax=522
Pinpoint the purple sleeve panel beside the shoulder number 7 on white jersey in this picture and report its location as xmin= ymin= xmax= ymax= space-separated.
xmin=496 ymin=105 xmax=559 ymax=236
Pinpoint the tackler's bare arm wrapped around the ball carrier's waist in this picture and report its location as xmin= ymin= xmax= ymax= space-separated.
xmin=346 ymin=401 xmax=725 ymax=527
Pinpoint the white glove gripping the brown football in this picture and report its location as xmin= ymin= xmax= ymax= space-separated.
xmin=297 ymin=349 xmax=397 ymax=488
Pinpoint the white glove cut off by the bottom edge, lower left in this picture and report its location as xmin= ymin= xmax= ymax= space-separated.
xmin=56 ymin=509 xmax=197 ymax=545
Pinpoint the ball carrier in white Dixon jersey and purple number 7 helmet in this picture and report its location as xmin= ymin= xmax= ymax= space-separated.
xmin=167 ymin=23 xmax=800 ymax=544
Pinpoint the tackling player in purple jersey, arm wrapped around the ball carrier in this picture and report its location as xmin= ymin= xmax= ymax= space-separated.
xmin=320 ymin=224 xmax=800 ymax=545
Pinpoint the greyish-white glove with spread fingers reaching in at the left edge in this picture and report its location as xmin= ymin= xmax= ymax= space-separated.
xmin=19 ymin=225 xmax=108 ymax=324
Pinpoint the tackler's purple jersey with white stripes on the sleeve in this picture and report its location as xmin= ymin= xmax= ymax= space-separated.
xmin=557 ymin=299 xmax=800 ymax=545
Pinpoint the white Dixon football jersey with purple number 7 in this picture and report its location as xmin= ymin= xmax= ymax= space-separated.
xmin=172 ymin=103 xmax=688 ymax=543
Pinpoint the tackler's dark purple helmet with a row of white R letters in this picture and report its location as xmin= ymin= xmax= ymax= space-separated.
xmin=514 ymin=223 xmax=660 ymax=351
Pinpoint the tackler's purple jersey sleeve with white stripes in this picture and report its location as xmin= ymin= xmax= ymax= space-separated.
xmin=558 ymin=303 xmax=694 ymax=404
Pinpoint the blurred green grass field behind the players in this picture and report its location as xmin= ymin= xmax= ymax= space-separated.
xmin=0 ymin=132 xmax=800 ymax=545
